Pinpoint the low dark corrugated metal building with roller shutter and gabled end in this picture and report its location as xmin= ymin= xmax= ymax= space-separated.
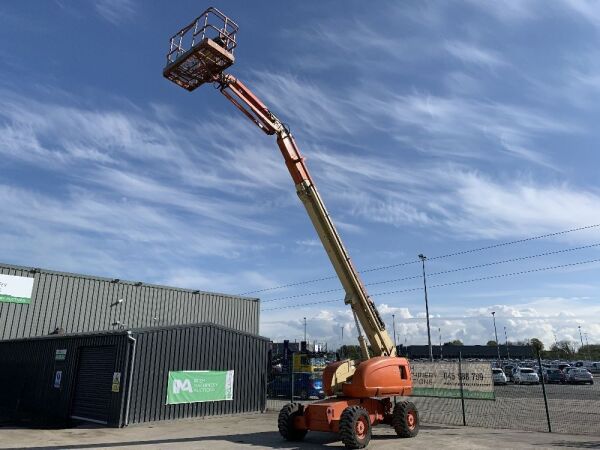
xmin=0 ymin=323 xmax=269 ymax=427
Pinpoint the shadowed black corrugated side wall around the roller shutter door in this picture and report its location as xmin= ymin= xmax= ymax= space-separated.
xmin=0 ymin=332 xmax=130 ymax=426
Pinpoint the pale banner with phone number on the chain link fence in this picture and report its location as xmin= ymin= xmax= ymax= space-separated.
xmin=411 ymin=361 xmax=495 ymax=400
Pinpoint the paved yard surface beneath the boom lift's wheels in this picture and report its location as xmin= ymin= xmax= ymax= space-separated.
xmin=0 ymin=413 xmax=600 ymax=450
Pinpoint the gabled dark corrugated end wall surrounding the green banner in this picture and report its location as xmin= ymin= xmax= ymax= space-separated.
xmin=129 ymin=324 xmax=269 ymax=423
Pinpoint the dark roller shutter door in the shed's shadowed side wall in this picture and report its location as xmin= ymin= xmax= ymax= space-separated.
xmin=71 ymin=346 xmax=116 ymax=424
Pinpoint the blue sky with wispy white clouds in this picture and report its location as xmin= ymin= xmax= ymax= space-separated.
xmin=0 ymin=0 xmax=600 ymax=345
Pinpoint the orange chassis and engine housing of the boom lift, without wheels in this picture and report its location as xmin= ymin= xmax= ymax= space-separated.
xmin=294 ymin=356 xmax=412 ymax=433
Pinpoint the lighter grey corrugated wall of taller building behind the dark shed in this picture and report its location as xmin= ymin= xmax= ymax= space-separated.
xmin=0 ymin=264 xmax=260 ymax=339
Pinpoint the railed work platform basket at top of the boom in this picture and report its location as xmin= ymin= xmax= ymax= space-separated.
xmin=163 ymin=7 xmax=238 ymax=91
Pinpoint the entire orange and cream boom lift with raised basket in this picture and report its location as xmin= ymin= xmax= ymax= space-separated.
xmin=163 ymin=7 xmax=418 ymax=448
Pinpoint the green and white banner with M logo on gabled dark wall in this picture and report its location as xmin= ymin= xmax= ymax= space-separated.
xmin=167 ymin=370 xmax=233 ymax=405
